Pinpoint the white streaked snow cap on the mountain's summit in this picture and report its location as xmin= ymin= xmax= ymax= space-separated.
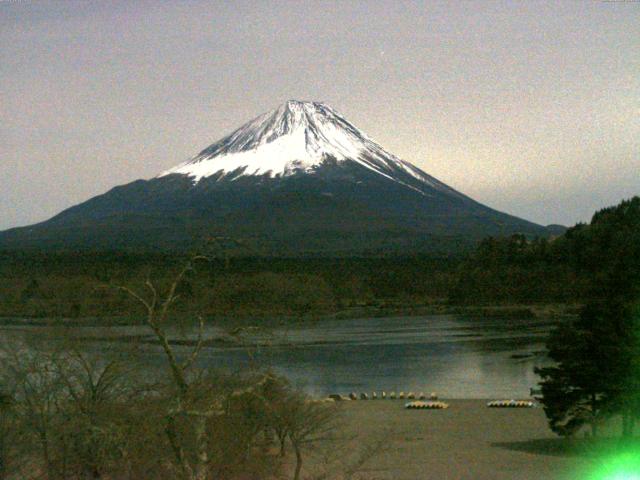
xmin=159 ymin=100 xmax=448 ymax=193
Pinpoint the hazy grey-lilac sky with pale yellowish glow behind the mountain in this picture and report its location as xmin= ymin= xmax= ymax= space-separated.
xmin=0 ymin=0 xmax=640 ymax=229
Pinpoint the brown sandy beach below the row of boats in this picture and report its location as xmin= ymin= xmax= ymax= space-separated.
xmin=328 ymin=400 xmax=589 ymax=480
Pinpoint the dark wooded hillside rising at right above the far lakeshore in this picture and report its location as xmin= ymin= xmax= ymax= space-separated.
xmin=450 ymin=197 xmax=640 ymax=303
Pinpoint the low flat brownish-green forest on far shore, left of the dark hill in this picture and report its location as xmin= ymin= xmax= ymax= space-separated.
xmin=0 ymin=252 xmax=459 ymax=317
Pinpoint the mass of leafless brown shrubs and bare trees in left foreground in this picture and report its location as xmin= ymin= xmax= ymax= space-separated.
xmin=0 ymin=253 xmax=384 ymax=480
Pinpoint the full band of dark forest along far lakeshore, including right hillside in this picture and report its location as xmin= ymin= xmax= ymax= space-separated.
xmin=0 ymin=197 xmax=640 ymax=317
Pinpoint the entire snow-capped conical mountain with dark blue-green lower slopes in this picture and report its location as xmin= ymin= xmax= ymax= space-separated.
xmin=0 ymin=100 xmax=550 ymax=255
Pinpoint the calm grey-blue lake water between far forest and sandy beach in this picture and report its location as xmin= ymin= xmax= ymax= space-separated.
xmin=0 ymin=315 xmax=553 ymax=398
